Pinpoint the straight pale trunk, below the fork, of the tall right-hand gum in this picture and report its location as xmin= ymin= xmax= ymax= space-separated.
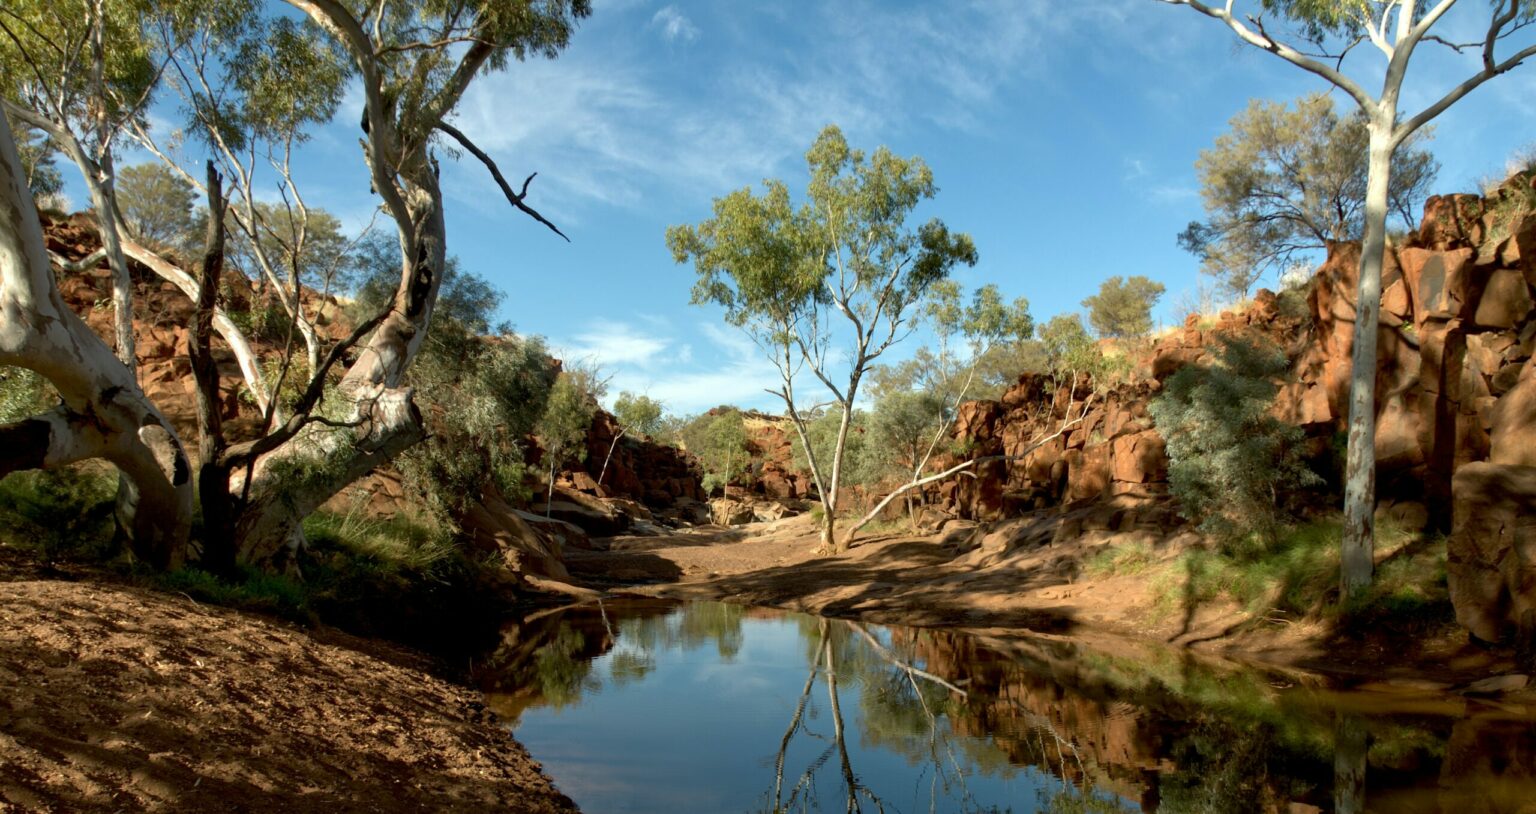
xmin=1339 ymin=126 xmax=1393 ymax=597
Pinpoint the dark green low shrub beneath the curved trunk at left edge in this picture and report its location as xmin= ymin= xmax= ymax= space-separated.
xmin=0 ymin=464 xmax=117 ymax=559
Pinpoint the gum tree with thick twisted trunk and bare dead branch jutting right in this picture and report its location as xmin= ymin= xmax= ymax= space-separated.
xmin=230 ymin=0 xmax=591 ymax=562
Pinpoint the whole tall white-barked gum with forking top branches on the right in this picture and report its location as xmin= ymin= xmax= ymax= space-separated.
xmin=1158 ymin=0 xmax=1536 ymax=596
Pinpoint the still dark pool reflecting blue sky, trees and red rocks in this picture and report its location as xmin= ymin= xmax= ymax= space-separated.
xmin=478 ymin=602 xmax=1536 ymax=814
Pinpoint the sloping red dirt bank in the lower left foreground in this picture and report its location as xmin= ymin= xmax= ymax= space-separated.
xmin=0 ymin=547 xmax=576 ymax=814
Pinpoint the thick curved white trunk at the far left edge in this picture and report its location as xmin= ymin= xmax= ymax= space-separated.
xmin=0 ymin=109 xmax=192 ymax=568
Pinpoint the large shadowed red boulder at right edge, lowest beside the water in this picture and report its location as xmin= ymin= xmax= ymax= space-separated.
xmin=1445 ymin=462 xmax=1536 ymax=642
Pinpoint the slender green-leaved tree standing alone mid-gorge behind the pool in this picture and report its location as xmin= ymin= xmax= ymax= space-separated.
xmin=667 ymin=126 xmax=977 ymax=551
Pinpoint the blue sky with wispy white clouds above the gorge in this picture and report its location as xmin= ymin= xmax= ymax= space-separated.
xmin=96 ymin=0 xmax=1536 ymax=415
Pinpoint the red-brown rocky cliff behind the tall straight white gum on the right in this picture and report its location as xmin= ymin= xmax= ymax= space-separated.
xmin=931 ymin=174 xmax=1536 ymax=640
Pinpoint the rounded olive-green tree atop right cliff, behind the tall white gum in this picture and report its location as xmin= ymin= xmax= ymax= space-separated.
xmin=1178 ymin=92 xmax=1439 ymax=298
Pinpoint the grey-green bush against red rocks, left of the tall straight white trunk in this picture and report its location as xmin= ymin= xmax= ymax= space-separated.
xmin=1150 ymin=338 xmax=1321 ymax=545
